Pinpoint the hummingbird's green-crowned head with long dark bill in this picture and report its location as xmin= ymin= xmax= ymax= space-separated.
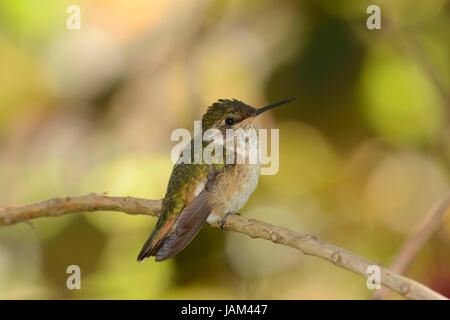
xmin=202 ymin=98 xmax=295 ymax=131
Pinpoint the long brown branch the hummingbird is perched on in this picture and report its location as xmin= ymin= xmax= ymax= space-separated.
xmin=0 ymin=194 xmax=446 ymax=299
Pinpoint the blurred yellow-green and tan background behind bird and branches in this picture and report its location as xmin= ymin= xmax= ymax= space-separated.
xmin=0 ymin=0 xmax=450 ymax=299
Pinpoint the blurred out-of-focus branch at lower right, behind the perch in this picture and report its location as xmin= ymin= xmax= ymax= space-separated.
xmin=372 ymin=192 xmax=450 ymax=299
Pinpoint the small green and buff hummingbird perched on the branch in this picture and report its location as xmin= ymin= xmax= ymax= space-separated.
xmin=137 ymin=98 xmax=295 ymax=261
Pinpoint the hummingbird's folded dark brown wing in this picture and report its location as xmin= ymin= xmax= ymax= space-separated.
xmin=156 ymin=178 xmax=214 ymax=261
